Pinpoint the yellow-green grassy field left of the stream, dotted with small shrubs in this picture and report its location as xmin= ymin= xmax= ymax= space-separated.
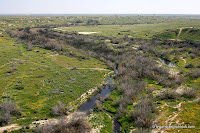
xmin=0 ymin=34 xmax=109 ymax=125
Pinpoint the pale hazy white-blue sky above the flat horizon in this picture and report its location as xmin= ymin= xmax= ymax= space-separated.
xmin=0 ymin=0 xmax=200 ymax=14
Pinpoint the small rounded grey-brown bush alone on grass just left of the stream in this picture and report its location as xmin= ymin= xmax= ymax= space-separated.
xmin=51 ymin=101 xmax=67 ymax=116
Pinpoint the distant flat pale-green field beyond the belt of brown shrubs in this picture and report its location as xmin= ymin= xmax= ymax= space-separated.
xmin=56 ymin=20 xmax=200 ymax=39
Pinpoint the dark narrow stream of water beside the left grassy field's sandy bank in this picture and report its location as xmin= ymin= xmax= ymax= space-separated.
xmin=78 ymin=73 xmax=121 ymax=133
